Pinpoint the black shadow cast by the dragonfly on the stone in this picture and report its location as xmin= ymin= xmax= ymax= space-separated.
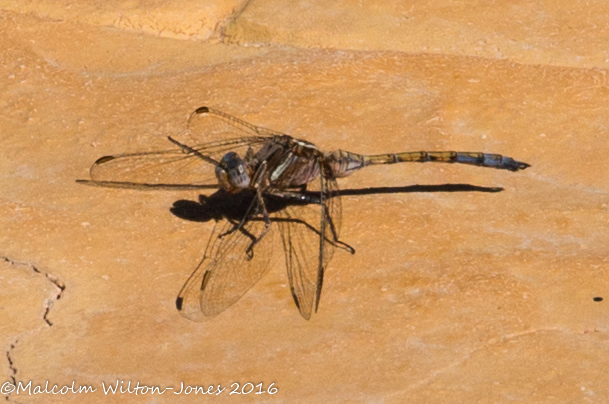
xmin=170 ymin=184 xmax=503 ymax=222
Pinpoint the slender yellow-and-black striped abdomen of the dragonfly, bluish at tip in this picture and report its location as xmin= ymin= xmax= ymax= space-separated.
xmin=324 ymin=150 xmax=529 ymax=177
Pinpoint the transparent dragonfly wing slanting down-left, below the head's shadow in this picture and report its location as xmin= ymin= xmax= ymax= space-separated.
xmin=176 ymin=205 xmax=273 ymax=321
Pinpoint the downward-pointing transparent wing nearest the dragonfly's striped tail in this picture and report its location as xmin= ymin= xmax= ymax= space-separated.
xmin=276 ymin=166 xmax=341 ymax=320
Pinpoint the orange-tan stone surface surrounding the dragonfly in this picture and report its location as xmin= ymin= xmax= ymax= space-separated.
xmin=0 ymin=1 xmax=609 ymax=403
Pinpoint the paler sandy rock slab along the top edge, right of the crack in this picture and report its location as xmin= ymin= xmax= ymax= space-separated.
xmin=223 ymin=0 xmax=609 ymax=68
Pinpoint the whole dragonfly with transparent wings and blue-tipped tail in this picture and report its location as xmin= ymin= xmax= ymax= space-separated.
xmin=78 ymin=107 xmax=530 ymax=321
